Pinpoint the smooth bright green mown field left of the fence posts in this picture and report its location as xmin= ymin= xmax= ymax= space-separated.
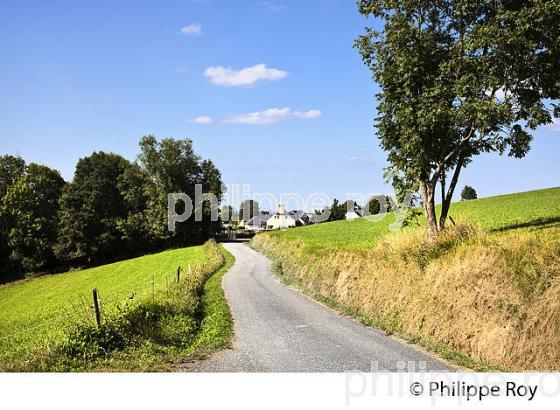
xmin=0 ymin=246 xmax=207 ymax=369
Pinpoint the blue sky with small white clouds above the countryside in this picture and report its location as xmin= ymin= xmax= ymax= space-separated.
xmin=0 ymin=0 xmax=560 ymax=210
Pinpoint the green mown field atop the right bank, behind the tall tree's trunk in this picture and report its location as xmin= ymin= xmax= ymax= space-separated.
xmin=265 ymin=188 xmax=560 ymax=253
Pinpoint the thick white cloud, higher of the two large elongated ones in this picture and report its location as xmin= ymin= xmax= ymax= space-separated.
xmin=204 ymin=64 xmax=288 ymax=87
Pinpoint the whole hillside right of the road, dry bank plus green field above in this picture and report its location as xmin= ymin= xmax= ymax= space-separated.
xmin=252 ymin=188 xmax=560 ymax=370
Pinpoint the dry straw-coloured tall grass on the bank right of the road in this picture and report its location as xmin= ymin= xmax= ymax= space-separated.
xmin=253 ymin=222 xmax=560 ymax=370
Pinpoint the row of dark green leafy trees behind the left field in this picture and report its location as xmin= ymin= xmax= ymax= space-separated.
xmin=0 ymin=136 xmax=222 ymax=282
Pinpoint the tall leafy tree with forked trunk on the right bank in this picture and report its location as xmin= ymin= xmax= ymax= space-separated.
xmin=356 ymin=0 xmax=560 ymax=237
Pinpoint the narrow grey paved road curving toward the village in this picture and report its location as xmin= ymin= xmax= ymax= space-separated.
xmin=191 ymin=243 xmax=454 ymax=372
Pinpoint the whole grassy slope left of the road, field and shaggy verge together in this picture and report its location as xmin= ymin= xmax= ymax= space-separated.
xmin=0 ymin=241 xmax=234 ymax=371
